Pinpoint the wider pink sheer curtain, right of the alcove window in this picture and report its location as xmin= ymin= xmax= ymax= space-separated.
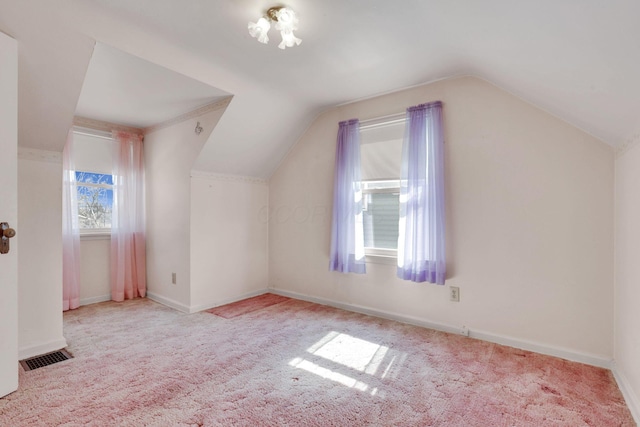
xmin=111 ymin=132 xmax=146 ymax=301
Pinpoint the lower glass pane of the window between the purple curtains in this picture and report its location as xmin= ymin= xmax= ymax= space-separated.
xmin=363 ymin=193 xmax=400 ymax=249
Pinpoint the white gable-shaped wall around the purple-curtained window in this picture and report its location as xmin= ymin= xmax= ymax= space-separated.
xmin=269 ymin=77 xmax=614 ymax=364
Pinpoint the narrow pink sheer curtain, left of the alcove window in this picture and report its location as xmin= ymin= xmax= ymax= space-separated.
xmin=62 ymin=131 xmax=80 ymax=311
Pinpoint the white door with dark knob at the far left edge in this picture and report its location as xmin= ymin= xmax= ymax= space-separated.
xmin=0 ymin=32 xmax=20 ymax=397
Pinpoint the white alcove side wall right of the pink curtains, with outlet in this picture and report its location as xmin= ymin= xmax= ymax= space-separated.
xmin=144 ymin=103 xmax=224 ymax=311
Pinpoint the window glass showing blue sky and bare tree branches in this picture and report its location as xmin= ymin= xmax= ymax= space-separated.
xmin=76 ymin=171 xmax=113 ymax=233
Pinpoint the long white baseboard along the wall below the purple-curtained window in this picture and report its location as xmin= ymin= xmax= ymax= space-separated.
xmin=269 ymin=288 xmax=612 ymax=369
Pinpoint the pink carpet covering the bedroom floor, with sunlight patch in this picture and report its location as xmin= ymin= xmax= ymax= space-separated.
xmin=0 ymin=299 xmax=635 ymax=427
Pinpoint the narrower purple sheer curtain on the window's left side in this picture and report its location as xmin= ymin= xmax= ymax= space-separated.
xmin=329 ymin=119 xmax=366 ymax=274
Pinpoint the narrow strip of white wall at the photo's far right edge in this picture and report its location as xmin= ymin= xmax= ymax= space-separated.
xmin=614 ymin=144 xmax=640 ymax=420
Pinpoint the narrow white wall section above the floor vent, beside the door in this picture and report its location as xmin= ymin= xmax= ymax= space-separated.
xmin=18 ymin=148 xmax=66 ymax=359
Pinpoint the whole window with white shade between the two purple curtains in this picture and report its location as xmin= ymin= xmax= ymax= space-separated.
xmin=360 ymin=118 xmax=405 ymax=257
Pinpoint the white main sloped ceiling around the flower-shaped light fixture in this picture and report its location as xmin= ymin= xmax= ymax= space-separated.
xmin=0 ymin=0 xmax=640 ymax=177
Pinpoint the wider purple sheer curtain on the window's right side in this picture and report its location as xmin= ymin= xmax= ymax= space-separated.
xmin=397 ymin=101 xmax=446 ymax=285
